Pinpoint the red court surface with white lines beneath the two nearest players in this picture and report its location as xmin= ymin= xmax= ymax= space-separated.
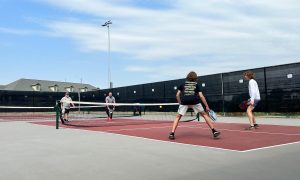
xmin=32 ymin=120 xmax=300 ymax=152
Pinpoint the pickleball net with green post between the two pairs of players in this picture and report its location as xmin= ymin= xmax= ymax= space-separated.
xmin=56 ymin=101 xmax=199 ymax=128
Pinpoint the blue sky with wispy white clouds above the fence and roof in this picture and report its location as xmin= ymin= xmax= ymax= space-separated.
xmin=0 ymin=0 xmax=300 ymax=89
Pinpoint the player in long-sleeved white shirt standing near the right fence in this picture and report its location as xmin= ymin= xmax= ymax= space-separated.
xmin=244 ymin=71 xmax=260 ymax=130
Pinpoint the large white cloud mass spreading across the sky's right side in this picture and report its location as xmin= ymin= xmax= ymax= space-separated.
xmin=12 ymin=0 xmax=300 ymax=84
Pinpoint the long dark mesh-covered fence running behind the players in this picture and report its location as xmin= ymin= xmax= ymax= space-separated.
xmin=0 ymin=63 xmax=300 ymax=112
